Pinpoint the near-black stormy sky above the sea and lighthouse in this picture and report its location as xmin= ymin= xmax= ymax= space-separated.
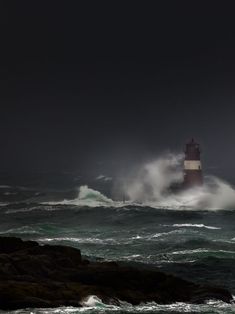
xmin=0 ymin=0 xmax=235 ymax=179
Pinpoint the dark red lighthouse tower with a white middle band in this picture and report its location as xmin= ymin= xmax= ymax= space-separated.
xmin=184 ymin=139 xmax=203 ymax=188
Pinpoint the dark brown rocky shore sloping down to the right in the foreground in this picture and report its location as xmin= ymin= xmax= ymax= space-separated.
xmin=0 ymin=237 xmax=232 ymax=310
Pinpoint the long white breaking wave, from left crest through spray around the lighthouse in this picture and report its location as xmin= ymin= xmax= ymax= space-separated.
xmin=40 ymin=153 xmax=235 ymax=210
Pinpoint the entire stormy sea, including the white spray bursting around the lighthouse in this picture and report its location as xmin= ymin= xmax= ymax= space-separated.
xmin=0 ymin=154 xmax=235 ymax=314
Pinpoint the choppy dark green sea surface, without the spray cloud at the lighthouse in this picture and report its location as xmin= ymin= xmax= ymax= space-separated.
xmin=0 ymin=174 xmax=235 ymax=313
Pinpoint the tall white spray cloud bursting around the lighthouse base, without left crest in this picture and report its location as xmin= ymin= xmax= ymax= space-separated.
xmin=114 ymin=153 xmax=235 ymax=209
